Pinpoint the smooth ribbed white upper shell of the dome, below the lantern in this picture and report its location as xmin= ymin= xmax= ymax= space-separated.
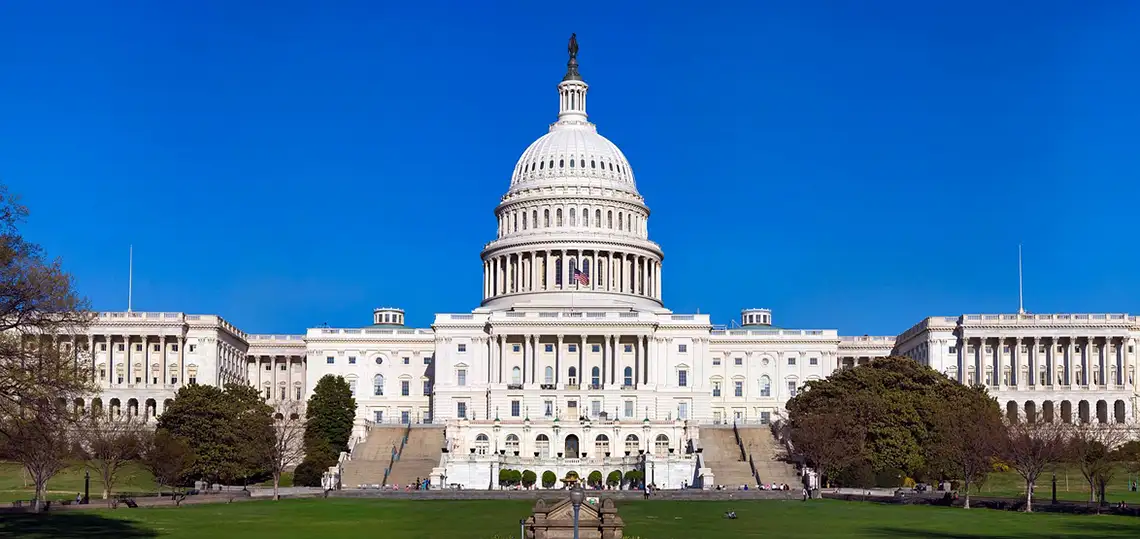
xmin=510 ymin=122 xmax=637 ymax=194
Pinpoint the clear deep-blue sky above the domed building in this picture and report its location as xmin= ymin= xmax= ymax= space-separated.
xmin=0 ymin=0 xmax=1140 ymax=335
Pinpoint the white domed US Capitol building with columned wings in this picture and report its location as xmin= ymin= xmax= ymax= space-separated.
xmin=75 ymin=41 xmax=1140 ymax=488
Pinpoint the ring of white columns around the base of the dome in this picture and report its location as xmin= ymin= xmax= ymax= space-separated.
xmin=483 ymin=250 xmax=661 ymax=300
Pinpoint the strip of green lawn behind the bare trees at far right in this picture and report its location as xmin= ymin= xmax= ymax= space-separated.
xmin=970 ymin=467 xmax=1140 ymax=505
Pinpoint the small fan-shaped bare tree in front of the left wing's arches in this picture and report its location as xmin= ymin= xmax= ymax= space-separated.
xmin=78 ymin=414 xmax=145 ymax=499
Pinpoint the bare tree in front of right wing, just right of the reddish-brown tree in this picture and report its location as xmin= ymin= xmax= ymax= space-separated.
xmin=998 ymin=414 xmax=1068 ymax=513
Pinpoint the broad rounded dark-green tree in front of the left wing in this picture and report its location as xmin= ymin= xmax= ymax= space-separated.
xmin=158 ymin=384 xmax=274 ymax=482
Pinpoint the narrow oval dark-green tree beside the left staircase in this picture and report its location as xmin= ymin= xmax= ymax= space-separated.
xmin=304 ymin=375 xmax=356 ymax=455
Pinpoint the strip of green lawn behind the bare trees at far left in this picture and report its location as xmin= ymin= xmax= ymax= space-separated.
xmin=0 ymin=462 xmax=158 ymax=503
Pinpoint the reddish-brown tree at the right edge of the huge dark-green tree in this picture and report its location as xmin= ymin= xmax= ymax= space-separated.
xmin=934 ymin=385 xmax=1002 ymax=509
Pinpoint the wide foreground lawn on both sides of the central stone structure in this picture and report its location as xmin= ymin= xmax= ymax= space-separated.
xmin=0 ymin=498 xmax=1140 ymax=539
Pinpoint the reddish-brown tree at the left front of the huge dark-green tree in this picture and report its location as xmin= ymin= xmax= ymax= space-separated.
xmin=789 ymin=411 xmax=866 ymax=489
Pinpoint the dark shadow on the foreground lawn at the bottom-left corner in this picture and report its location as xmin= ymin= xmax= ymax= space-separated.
xmin=0 ymin=511 xmax=158 ymax=539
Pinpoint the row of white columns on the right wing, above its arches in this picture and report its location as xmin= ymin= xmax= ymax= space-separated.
xmin=958 ymin=336 xmax=1135 ymax=390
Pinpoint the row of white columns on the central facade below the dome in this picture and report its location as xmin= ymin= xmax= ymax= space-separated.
xmin=487 ymin=334 xmax=654 ymax=389
